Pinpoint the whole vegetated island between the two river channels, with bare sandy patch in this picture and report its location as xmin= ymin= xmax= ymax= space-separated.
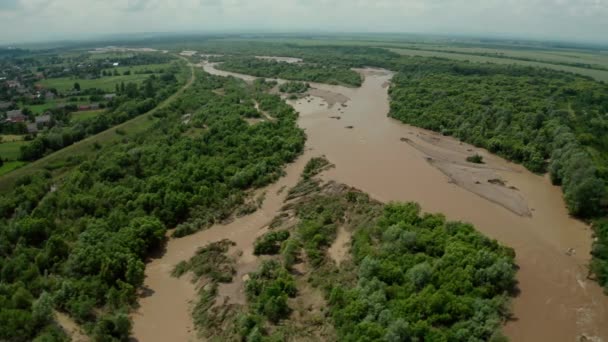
xmin=276 ymin=164 xmax=516 ymax=341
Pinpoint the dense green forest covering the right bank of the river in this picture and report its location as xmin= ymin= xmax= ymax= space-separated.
xmin=390 ymin=60 xmax=608 ymax=217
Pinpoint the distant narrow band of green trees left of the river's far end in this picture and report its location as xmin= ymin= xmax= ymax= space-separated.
xmin=218 ymin=57 xmax=362 ymax=87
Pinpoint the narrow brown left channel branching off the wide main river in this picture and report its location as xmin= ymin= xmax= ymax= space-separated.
xmin=132 ymin=151 xmax=311 ymax=342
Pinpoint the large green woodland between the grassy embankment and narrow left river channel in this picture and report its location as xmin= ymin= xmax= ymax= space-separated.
xmin=0 ymin=74 xmax=305 ymax=341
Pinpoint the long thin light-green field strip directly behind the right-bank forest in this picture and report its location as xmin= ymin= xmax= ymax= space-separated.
xmin=390 ymin=48 xmax=608 ymax=82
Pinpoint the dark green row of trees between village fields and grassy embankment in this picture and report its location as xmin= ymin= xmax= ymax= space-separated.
xmin=20 ymin=67 xmax=180 ymax=161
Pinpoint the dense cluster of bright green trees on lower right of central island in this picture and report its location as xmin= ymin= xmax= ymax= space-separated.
xmin=329 ymin=203 xmax=515 ymax=341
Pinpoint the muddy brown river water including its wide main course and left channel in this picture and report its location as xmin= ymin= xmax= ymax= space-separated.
xmin=133 ymin=64 xmax=608 ymax=341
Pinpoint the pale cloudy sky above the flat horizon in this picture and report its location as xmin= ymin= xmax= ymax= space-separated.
xmin=0 ymin=0 xmax=608 ymax=43
